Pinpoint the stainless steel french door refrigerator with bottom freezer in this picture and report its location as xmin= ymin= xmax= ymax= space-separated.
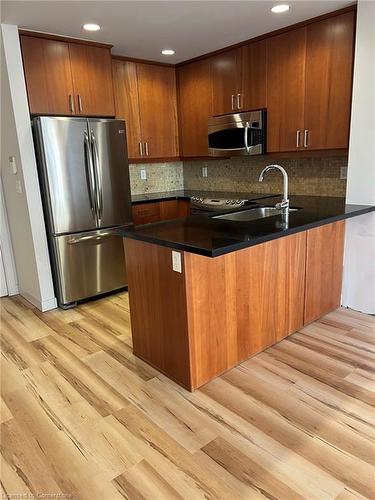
xmin=32 ymin=116 xmax=132 ymax=308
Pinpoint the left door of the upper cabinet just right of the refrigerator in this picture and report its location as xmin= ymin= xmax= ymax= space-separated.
xmin=112 ymin=60 xmax=142 ymax=158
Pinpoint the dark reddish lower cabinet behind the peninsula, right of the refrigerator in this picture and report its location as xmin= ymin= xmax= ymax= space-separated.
xmin=132 ymin=200 xmax=190 ymax=225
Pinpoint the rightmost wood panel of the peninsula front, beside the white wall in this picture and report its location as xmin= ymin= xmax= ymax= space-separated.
xmin=304 ymin=221 xmax=345 ymax=324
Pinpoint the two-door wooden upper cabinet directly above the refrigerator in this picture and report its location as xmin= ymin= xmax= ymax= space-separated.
xmin=20 ymin=35 xmax=115 ymax=116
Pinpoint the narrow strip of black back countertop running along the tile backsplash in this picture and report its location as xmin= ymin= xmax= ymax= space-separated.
xmin=132 ymin=189 xmax=279 ymax=205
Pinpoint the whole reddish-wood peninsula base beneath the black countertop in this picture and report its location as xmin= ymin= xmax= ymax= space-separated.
xmin=125 ymin=222 xmax=344 ymax=390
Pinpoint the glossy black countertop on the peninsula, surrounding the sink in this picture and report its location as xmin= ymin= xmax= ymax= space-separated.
xmin=122 ymin=193 xmax=375 ymax=257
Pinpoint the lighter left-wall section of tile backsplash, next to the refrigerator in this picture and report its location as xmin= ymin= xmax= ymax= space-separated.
xmin=129 ymin=162 xmax=184 ymax=194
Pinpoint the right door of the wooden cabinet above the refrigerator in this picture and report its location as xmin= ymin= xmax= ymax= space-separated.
xmin=69 ymin=43 xmax=115 ymax=116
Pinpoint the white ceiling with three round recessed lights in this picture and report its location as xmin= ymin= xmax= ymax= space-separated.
xmin=1 ymin=0 xmax=353 ymax=63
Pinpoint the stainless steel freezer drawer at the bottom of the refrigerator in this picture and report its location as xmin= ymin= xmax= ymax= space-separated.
xmin=52 ymin=227 xmax=127 ymax=306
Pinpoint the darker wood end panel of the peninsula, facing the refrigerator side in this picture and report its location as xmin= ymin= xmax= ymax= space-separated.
xmin=124 ymin=239 xmax=190 ymax=388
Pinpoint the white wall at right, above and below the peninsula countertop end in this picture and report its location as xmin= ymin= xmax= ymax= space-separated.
xmin=342 ymin=0 xmax=375 ymax=314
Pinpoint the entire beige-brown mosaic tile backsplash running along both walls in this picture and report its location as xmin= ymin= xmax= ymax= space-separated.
xmin=129 ymin=156 xmax=348 ymax=196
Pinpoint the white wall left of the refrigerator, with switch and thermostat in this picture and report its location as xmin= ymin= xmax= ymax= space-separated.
xmin=1 ymin=24 xmax=56 ymax=310
